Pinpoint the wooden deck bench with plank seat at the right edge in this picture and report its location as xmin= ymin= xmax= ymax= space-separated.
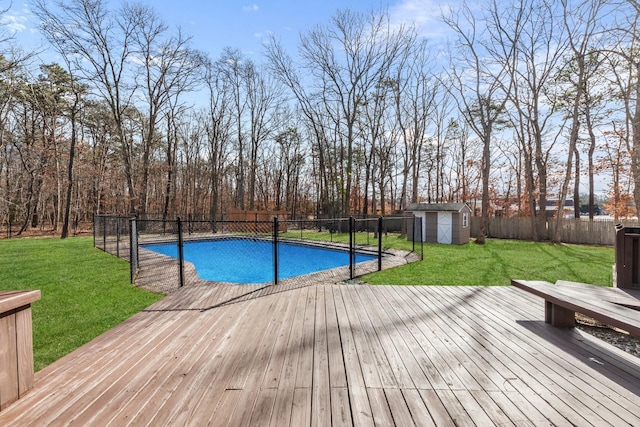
xmin=511 ymin=280 xmax=640 ymax=337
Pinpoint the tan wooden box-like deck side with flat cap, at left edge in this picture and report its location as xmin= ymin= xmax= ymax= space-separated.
xmin=0 ymin=291 xmax=40 ymax=411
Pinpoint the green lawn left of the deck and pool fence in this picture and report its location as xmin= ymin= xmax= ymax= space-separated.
xmin=0 ymin=237 xmax=163 ymax=371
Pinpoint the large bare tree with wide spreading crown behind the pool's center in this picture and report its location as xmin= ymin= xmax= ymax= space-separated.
xmin=267 ymin=10 xmax=411 ymax=214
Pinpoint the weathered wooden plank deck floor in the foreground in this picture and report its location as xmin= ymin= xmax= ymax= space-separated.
xmin=0 ymin=283 xmax=640 ymax=426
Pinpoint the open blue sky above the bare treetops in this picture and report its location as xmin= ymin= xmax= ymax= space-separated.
xmin=0 ymin=0 xmax=455 ymax=60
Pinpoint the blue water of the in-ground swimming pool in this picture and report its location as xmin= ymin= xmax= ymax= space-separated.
xmin=143 ymin=239 xmax=376 ymax=284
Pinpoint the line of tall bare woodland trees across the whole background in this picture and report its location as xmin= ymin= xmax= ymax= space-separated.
xmin=0 ymin=0 xmax=640 ymax=241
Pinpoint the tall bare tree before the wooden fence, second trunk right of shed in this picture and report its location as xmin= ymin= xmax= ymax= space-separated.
xmin=492 ymin=0 xmax=567 ymax=240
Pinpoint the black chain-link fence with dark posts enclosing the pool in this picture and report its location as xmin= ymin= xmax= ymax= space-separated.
xmin=94 ymin=215 xmax=423 ymax=293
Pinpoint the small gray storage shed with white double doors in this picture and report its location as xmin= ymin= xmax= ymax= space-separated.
xmin=405 ymin=203 xmax=471 ymax=245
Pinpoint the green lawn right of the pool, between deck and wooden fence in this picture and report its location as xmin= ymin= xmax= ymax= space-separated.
xmin=363 ymin=239 xmax=615 ymax=286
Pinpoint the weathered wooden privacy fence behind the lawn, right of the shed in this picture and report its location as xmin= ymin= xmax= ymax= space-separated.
xmin=471 ymin=217 xmax=640 ymax=246
